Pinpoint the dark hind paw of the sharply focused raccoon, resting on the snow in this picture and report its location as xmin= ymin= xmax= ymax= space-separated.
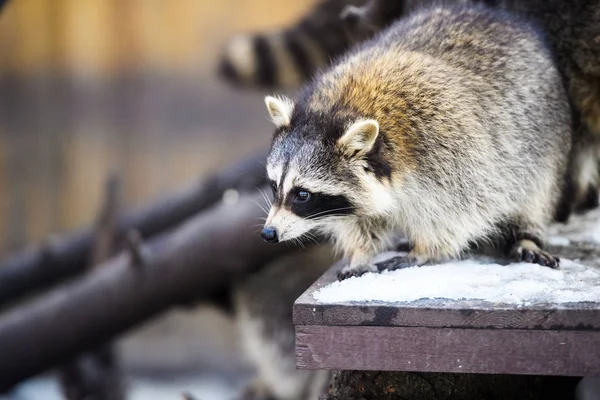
xmin=505 ymin=220 xmax=560 ymax=269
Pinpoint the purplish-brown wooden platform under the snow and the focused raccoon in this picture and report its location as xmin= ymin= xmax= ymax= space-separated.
xmin=294 ymin=250 xmax=600 ymax=376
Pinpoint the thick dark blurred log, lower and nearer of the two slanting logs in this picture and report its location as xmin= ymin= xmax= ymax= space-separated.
xmin=0 ymin=194 xmax=295 ymax=391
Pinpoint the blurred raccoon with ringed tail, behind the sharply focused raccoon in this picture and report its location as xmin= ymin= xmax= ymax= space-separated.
xmin=222 ymin=0 xmax=600 ymax=222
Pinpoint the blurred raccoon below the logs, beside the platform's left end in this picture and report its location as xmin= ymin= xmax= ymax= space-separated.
xmin=234 ymin=245 xmax=335 ymax=400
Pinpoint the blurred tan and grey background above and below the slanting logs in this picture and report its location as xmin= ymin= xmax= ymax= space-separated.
xmin=0 ymin=0 xmax=315 ymax=400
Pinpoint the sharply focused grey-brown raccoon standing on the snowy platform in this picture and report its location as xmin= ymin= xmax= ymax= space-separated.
xmin=262 ymin=6 xmax=572 ymax=279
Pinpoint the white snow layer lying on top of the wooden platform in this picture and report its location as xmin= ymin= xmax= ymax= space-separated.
xmin=313 ymin=254 xmax=600 ymax=306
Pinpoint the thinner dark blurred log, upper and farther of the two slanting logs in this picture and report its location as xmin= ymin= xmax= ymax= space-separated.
xmin=0 ymin=153 xmax=266 ymax=306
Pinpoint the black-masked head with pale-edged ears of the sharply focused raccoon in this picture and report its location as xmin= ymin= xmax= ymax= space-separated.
xmin=262 ymin=97 xmax=390 ymax=242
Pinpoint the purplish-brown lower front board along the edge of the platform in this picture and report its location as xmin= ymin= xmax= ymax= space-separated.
xmin=296 ymin=325 xmax=600 ymax=376
